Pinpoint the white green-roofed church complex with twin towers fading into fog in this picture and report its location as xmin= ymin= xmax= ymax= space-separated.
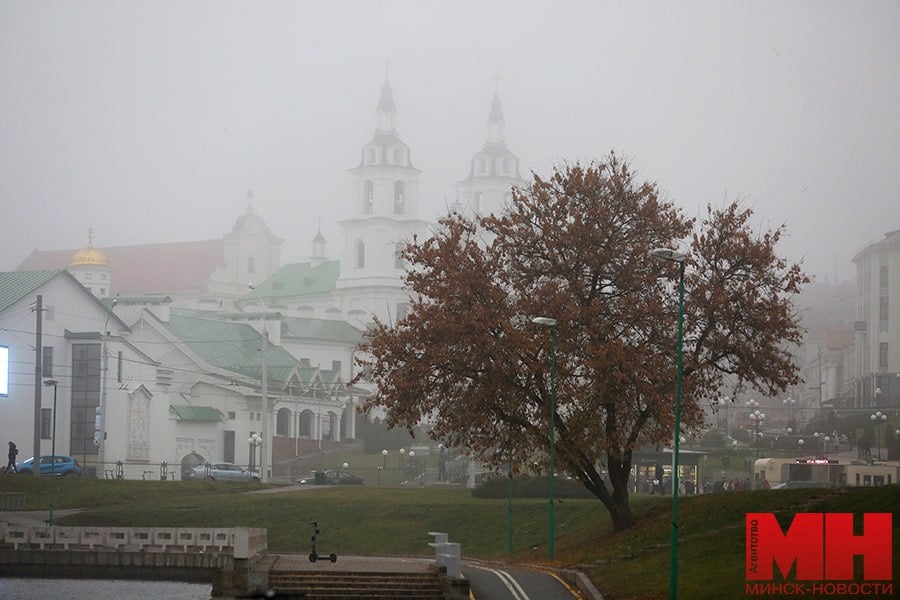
xmin=0 ymin=80 xmax=524 ymax=479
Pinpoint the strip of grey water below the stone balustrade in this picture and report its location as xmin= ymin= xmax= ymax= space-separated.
xmin=0 ymin=578 xmax=212 ymax=600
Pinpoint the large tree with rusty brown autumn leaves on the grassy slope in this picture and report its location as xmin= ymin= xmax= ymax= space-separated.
xmin=362 ymin=154 xmax=808 ymax=530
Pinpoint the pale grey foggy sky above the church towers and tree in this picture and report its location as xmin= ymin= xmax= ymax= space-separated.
xmin=0 ymin=0 xmax=900 ymax=280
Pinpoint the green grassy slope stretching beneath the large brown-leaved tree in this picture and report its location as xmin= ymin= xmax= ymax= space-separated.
xmin=0 ymin=477 xmax=900 ymax=600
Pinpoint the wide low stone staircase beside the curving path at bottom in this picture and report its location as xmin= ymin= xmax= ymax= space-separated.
xmin=269 ymin=570 xmax=446 ymax=600
